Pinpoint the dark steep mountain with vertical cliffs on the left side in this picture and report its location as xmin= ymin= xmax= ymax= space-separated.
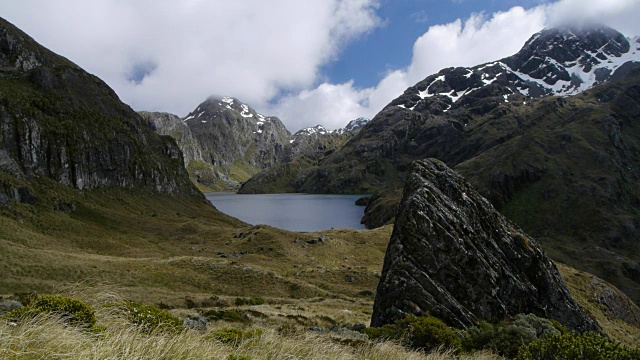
xmin=0 ymin=19 xmax=201 ymax=203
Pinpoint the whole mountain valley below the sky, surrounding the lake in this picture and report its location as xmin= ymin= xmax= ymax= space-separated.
xmin=0 ymin=9 xmax=640 ymax=360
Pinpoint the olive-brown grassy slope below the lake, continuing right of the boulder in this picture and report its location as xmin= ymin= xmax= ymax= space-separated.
xmin=0 ymin=179 xmax=640 ymax=345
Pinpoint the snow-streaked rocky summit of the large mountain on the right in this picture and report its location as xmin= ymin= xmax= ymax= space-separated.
xmin=392 ymin=26 xmax=640 ymax=111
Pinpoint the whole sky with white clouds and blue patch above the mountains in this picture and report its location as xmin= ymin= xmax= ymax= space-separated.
xmin=0 ymin=0 xmax=640 ymax=132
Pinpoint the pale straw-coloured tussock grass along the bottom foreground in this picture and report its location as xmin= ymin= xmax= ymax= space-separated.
xmin=0 ymin=290 xmax=497 ymax=360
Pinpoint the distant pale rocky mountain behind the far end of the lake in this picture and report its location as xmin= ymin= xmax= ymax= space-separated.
xmin=140 ymin=97 xmax=369 ymax=191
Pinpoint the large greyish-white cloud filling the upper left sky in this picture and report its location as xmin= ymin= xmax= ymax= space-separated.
xmin=2 ymin=0 xmax=380 ymax=121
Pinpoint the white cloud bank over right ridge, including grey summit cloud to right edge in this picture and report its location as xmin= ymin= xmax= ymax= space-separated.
xmin=274 ymin=0 xmax=640 ymax=128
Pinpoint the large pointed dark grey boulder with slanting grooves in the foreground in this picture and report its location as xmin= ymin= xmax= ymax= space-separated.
xmin=371 ymin=160 xmax=598 ymax=331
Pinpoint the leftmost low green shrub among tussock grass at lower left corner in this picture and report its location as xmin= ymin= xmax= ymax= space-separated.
xmin=5 ymin=295 xmax=96 ymax=327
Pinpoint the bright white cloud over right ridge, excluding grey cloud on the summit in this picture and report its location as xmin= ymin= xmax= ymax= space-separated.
xmin=272 ymin=7 xmax=545 ymax=128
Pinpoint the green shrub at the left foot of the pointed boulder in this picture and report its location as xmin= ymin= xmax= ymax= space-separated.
xmin=363 ymin=315 xmax=462 ymax=351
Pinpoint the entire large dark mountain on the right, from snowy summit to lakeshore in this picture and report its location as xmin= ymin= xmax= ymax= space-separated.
xmin=243 ymin=28 xmax=640 ymax=302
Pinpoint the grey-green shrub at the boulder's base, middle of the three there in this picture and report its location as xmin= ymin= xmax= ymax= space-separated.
xmin=464 ymin=314 xmax=562 ymax=358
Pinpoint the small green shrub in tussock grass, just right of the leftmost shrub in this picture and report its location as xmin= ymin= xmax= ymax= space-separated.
xmin=122 ymin=301 xmax=182 ymax=332
